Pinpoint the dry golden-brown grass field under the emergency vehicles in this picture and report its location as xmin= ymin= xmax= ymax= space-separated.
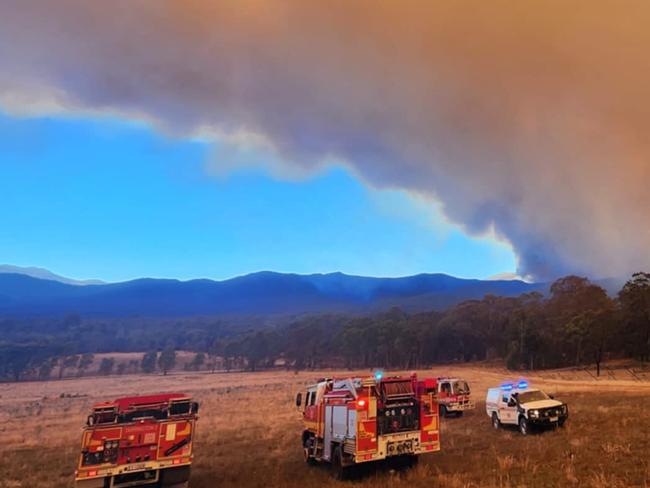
xmin=0 ymin=366 xmax=650 ymax=488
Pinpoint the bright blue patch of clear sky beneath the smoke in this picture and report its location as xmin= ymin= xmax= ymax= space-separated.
xmin=0 ymin=115 xmax=516 ymax=281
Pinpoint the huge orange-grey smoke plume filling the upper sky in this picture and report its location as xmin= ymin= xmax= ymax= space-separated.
xmin=0 ymin=0 xmax=650 ymax=280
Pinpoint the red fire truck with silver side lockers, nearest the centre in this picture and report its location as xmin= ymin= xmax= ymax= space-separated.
xmin=296 ymin=374 xmax=440 ymax=479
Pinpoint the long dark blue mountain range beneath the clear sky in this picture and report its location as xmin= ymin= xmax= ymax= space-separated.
xmin=0 ymin=272 xmax=548 ymax=317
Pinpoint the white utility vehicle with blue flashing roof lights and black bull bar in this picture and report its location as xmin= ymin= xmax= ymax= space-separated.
xmin=485 ymin=381 xmax=569 ymax=435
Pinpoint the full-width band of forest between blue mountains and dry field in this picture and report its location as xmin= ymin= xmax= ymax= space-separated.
xmin=0 ymin=273 xmax=650 ymax=381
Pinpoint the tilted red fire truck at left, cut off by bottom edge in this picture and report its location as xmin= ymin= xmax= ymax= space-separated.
xmin=75 ymin=393 xmax=199 ymax=488
